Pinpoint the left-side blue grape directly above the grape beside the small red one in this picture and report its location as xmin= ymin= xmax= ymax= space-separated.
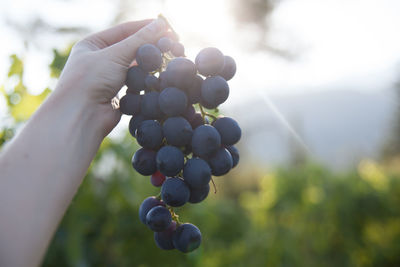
xmin=136 ymin=120 xmax=164 ymax=150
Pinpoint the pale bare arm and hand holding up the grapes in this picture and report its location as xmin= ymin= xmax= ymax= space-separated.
xmin=0 ymin=19 xmax=167 ymax=267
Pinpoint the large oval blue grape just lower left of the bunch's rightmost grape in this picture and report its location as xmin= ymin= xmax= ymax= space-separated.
xmin=192 ymin=125 xmax=221 ymax=158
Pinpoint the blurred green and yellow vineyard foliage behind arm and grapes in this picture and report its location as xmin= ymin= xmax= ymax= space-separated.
xmin=0 ymin=47 xmax=400 ymax=267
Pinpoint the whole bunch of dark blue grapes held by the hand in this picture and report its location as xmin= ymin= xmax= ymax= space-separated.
xmin=120 ymin=30 xmax=241 ymax=252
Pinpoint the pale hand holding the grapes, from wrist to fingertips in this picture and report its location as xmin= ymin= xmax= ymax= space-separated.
xmin=55 ymin=18 xmax=167 ymax=136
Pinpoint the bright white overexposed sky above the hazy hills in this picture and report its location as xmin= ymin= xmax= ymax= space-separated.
xmin=0 ymin=0 xmax=400 ymax=108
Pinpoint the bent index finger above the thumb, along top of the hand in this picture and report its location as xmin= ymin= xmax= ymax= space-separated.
xmin=83 ymin=19 xmax=153 ymax=49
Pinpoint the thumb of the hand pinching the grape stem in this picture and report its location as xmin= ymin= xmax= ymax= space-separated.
xmin=103 ymin=18 xmax=167 ymax=67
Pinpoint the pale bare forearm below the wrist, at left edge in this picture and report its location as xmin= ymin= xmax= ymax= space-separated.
xmin=0 ymin=88 xmax=106 ymax=266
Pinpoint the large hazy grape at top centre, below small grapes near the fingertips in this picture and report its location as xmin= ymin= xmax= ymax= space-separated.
xmin=166 ymin=57 xmax=196 ymax=91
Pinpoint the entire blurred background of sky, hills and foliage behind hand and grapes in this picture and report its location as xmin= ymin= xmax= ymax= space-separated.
xmin=0 ymin=0 xmax=400 ymax=267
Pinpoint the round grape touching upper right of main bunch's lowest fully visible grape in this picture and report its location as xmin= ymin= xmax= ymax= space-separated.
xmin=183 ymin=158 xmax=211 ymax=188
